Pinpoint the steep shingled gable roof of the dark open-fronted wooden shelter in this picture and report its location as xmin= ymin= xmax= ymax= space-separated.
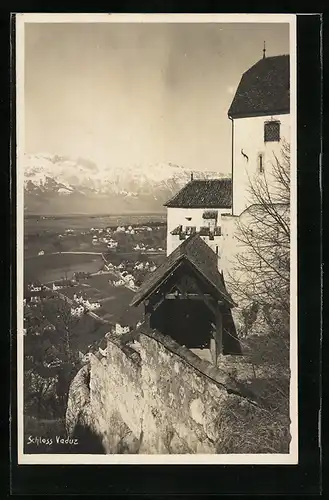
xmin=130 ymin=234 xmax=235 ymax=306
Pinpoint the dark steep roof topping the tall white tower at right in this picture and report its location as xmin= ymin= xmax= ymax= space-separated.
xmin=228 ymin=55 xmax=290 ymax=118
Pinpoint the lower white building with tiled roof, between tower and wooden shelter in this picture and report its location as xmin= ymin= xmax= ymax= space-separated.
xmin=164 ymin=175 xmax=232 ymax=262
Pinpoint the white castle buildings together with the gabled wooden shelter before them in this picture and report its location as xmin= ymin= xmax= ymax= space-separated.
xmin=131 ymin=53 xmax=290 ymax=365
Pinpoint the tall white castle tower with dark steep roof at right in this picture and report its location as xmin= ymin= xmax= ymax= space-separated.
xmin=228 ymin=52 xmax=290 ymax=216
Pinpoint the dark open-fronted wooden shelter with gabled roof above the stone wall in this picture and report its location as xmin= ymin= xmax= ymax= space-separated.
xmin=130 ymin=234 xmax=241 ymax=364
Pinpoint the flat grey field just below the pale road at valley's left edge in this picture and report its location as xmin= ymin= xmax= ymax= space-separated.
xmin=24 ymin=254 xmax=104 ymax=283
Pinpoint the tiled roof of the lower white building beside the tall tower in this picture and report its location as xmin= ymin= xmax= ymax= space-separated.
xmin=164 ymin=178 xmax=232 ymax=208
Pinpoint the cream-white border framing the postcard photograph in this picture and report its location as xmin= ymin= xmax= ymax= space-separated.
xmin=15 ymin=13 xmax=298 ymax=465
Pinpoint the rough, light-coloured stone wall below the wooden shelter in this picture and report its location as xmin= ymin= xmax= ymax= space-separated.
xmin=67 ymin=331 xmax=262 ymax=454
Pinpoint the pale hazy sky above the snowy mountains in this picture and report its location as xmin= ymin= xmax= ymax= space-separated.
xmin=24 ymin=23 xmax=289 ymax=174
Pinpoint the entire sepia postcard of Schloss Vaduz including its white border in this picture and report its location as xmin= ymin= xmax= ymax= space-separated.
xmin=15 ymin=13 xmax=298 ymax=464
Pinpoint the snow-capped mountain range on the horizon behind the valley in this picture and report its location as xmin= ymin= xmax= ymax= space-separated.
xmin=23 ymin=153 xmax=229 ymax=214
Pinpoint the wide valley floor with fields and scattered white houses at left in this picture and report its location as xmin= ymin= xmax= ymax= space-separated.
xmin=23 ymin=214 xmax=166 ymax=453
